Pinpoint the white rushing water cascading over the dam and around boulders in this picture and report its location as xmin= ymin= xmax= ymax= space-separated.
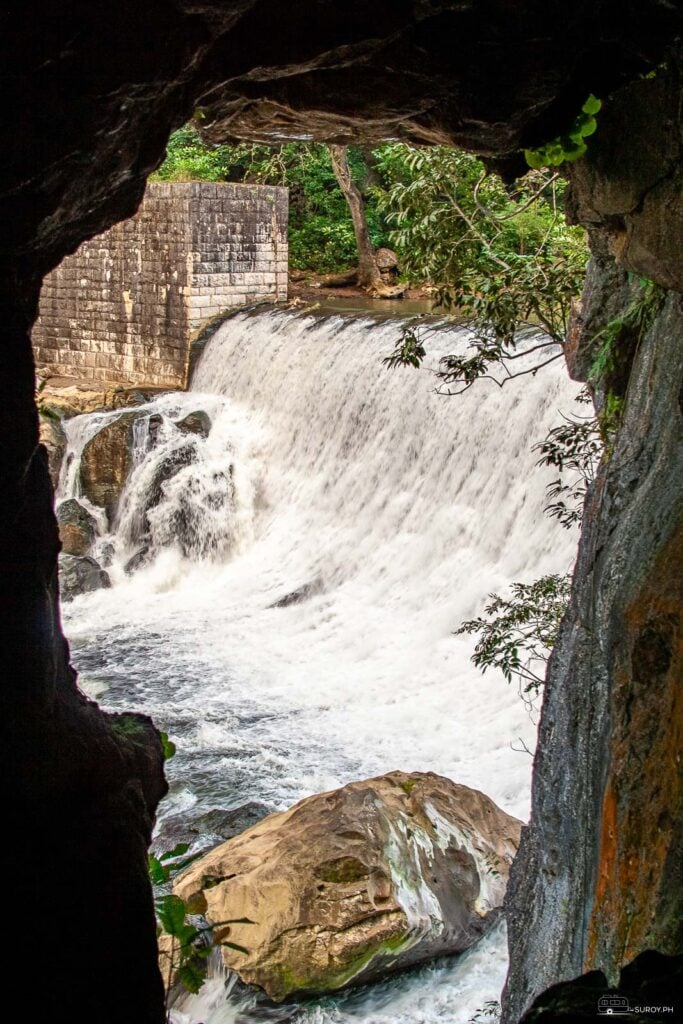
xmin=61 ymin=312 xmax=577 ymax=1024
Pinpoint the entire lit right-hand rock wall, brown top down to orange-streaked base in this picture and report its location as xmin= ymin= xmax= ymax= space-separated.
xmin=505 ymin=67 xmax=683 ymax=1021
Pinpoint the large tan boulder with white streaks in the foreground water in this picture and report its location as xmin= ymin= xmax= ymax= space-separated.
xmin=175 ymin=771 xmax=521 ymax=1001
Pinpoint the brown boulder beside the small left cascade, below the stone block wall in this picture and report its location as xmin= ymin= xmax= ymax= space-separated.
xmin=79 ymin=412 xmax=143 ymax=523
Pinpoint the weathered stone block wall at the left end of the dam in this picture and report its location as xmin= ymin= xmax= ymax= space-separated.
xmin=33 ymin=182 xmax=288 ymax=388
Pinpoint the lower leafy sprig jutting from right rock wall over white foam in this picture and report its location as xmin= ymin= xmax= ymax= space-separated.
xmin=456 ymin=574 xmax=571 ymax=699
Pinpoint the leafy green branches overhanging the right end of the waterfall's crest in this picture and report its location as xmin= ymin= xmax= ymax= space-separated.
xmin=376 ymin=143 xmax=588 ymax=394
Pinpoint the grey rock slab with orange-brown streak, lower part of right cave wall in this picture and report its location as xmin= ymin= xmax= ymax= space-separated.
xmin=505 ymin=293 xmax=683 ymax=1021
